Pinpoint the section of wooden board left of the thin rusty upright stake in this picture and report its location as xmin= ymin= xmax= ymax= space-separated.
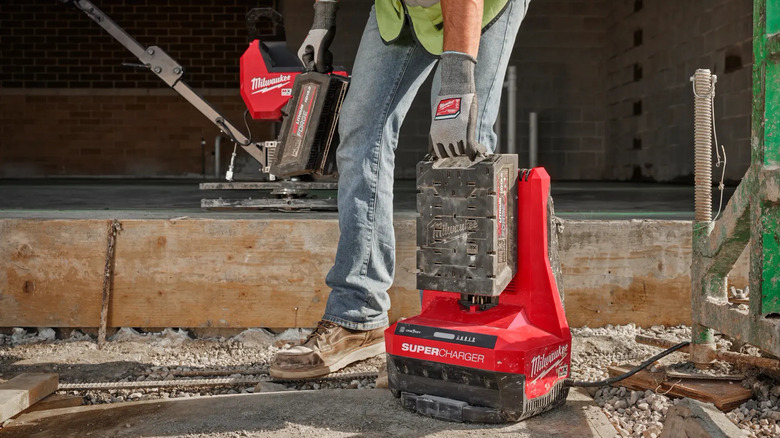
xmin=0 ymin=219 xmax=106 ymax=327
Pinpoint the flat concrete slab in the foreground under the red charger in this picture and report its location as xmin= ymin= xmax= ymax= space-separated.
xmin=0 ymin=389 xmax=615 ymax=438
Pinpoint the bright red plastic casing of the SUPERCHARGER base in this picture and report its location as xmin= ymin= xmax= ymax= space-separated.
xmin=385 ymin=167 xmax=571 ymax=399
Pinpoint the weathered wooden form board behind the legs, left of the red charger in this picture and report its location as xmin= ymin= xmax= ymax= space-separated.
xmin=0 ymin=215 xmax=420 ymax=327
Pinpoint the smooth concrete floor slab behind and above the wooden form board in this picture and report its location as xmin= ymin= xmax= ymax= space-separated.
xmin=0 ymin=179 xmax=733 ymax=220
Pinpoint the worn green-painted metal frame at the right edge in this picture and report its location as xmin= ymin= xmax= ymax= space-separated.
xmin=691 ymin=0 xmax=780 ymax=366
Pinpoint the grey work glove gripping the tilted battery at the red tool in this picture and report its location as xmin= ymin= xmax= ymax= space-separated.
xmin=298 ymin=0 xmax=339 ymax=73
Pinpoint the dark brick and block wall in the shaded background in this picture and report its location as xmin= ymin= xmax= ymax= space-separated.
xmin=0 ymin=0 xmax=751 ymax=181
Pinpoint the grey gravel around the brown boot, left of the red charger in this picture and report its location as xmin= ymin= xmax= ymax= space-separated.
xmin=0 ymin=328 xmax=384 ymax=404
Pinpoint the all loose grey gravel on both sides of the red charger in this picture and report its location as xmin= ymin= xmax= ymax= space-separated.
xmin=0 ymin=324 xmax=780 ymax=438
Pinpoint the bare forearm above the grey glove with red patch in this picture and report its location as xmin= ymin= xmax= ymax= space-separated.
xmin=441 ymin=0 xmax=484 ymax=59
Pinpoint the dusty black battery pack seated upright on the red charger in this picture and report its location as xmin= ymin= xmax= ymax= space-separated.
xmin=417 ymin=154 xmax=517 ymax=296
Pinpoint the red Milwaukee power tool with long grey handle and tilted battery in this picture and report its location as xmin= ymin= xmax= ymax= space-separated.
xmin=60 ymin=0 xmax=349 ymax=181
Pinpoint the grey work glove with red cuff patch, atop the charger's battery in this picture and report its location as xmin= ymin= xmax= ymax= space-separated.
xmin=430 ymin=52 xmax=487 ymax=161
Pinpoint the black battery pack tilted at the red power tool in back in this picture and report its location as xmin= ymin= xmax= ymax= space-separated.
xmin=271 ymin=72 xmax=349 ymax=177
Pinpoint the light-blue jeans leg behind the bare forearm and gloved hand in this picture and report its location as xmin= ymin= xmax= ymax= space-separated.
xmin=431 ymin=0 xmax=531 ymax=152
